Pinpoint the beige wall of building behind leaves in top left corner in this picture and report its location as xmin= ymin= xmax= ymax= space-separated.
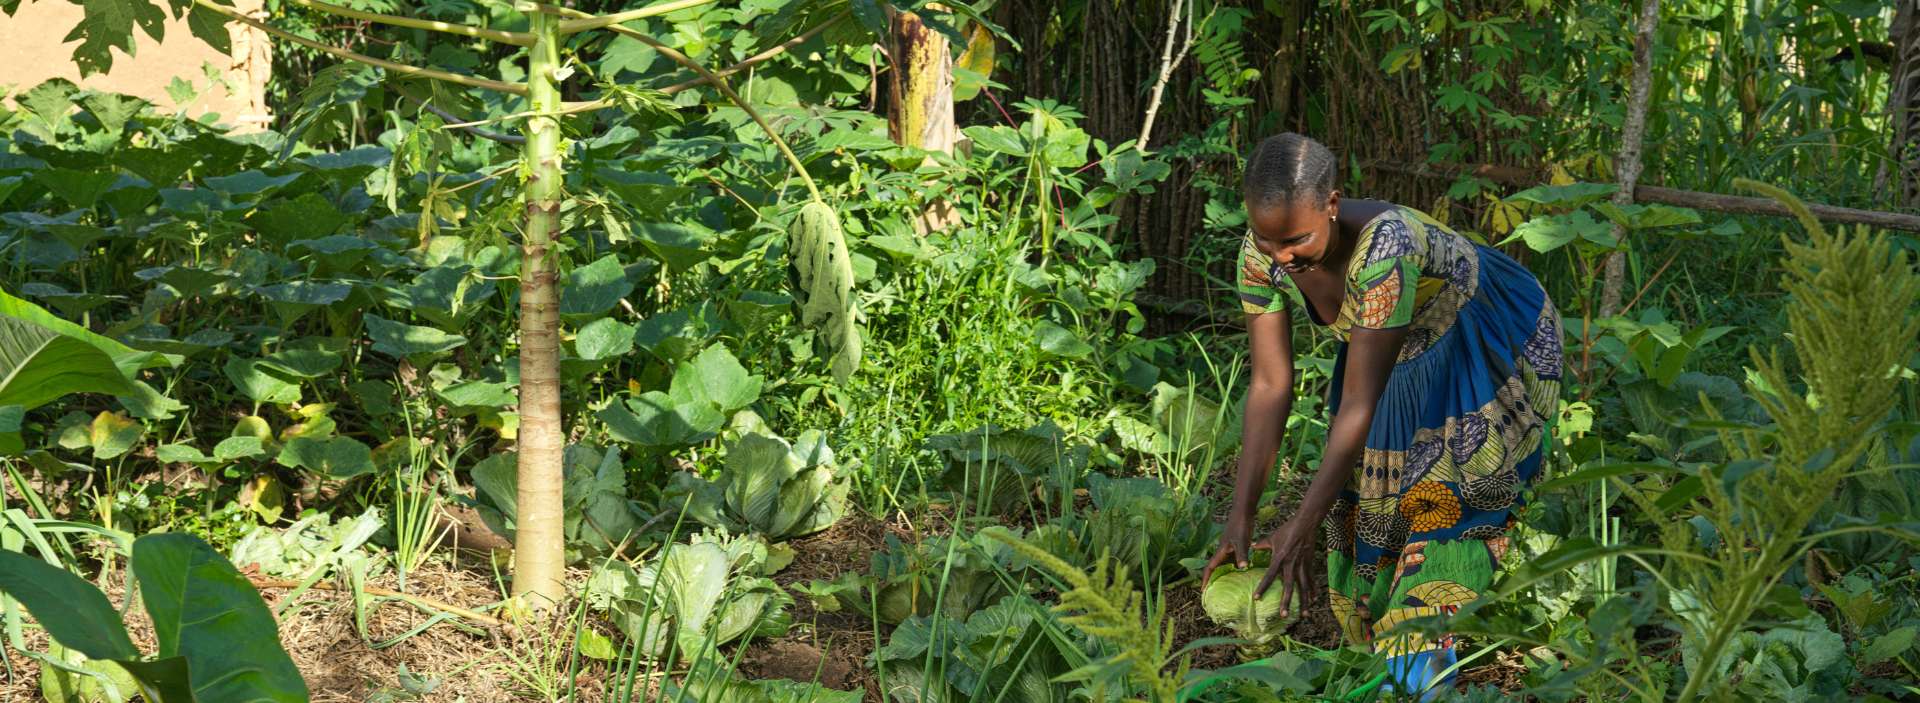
xmin=0 ymin=0 xmax=269 ymax=129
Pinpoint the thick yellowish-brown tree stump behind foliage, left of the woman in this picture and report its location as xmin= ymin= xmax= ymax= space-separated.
xmin=887 ymin=4 xmax=960 ymax=232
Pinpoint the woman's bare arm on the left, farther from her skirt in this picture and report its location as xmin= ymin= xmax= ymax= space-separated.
xmin=1200 ymin=309 xmax=1294 ymax=584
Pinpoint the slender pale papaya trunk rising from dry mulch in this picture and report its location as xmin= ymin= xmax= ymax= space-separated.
xmin=513 ymin=12 xmax=566 ymax=607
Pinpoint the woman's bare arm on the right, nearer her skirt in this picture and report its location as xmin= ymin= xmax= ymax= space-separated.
xmin=1254 ymin=327 xmax=1407 ymax=603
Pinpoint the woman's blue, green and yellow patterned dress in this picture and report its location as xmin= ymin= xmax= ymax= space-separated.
xmin=1238 ymin=207 xmax=1563 ymax=690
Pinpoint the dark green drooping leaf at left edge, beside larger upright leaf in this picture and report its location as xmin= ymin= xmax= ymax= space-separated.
xmin=0 ymin=549 xmax=140 ymax=659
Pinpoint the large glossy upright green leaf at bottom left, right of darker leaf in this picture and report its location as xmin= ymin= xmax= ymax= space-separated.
xmin=132 ymin=532 xmax=309 ymax=703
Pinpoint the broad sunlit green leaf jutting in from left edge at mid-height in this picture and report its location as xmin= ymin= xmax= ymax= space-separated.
xmin=0 ymin=311 xmax=132 ymax=409
